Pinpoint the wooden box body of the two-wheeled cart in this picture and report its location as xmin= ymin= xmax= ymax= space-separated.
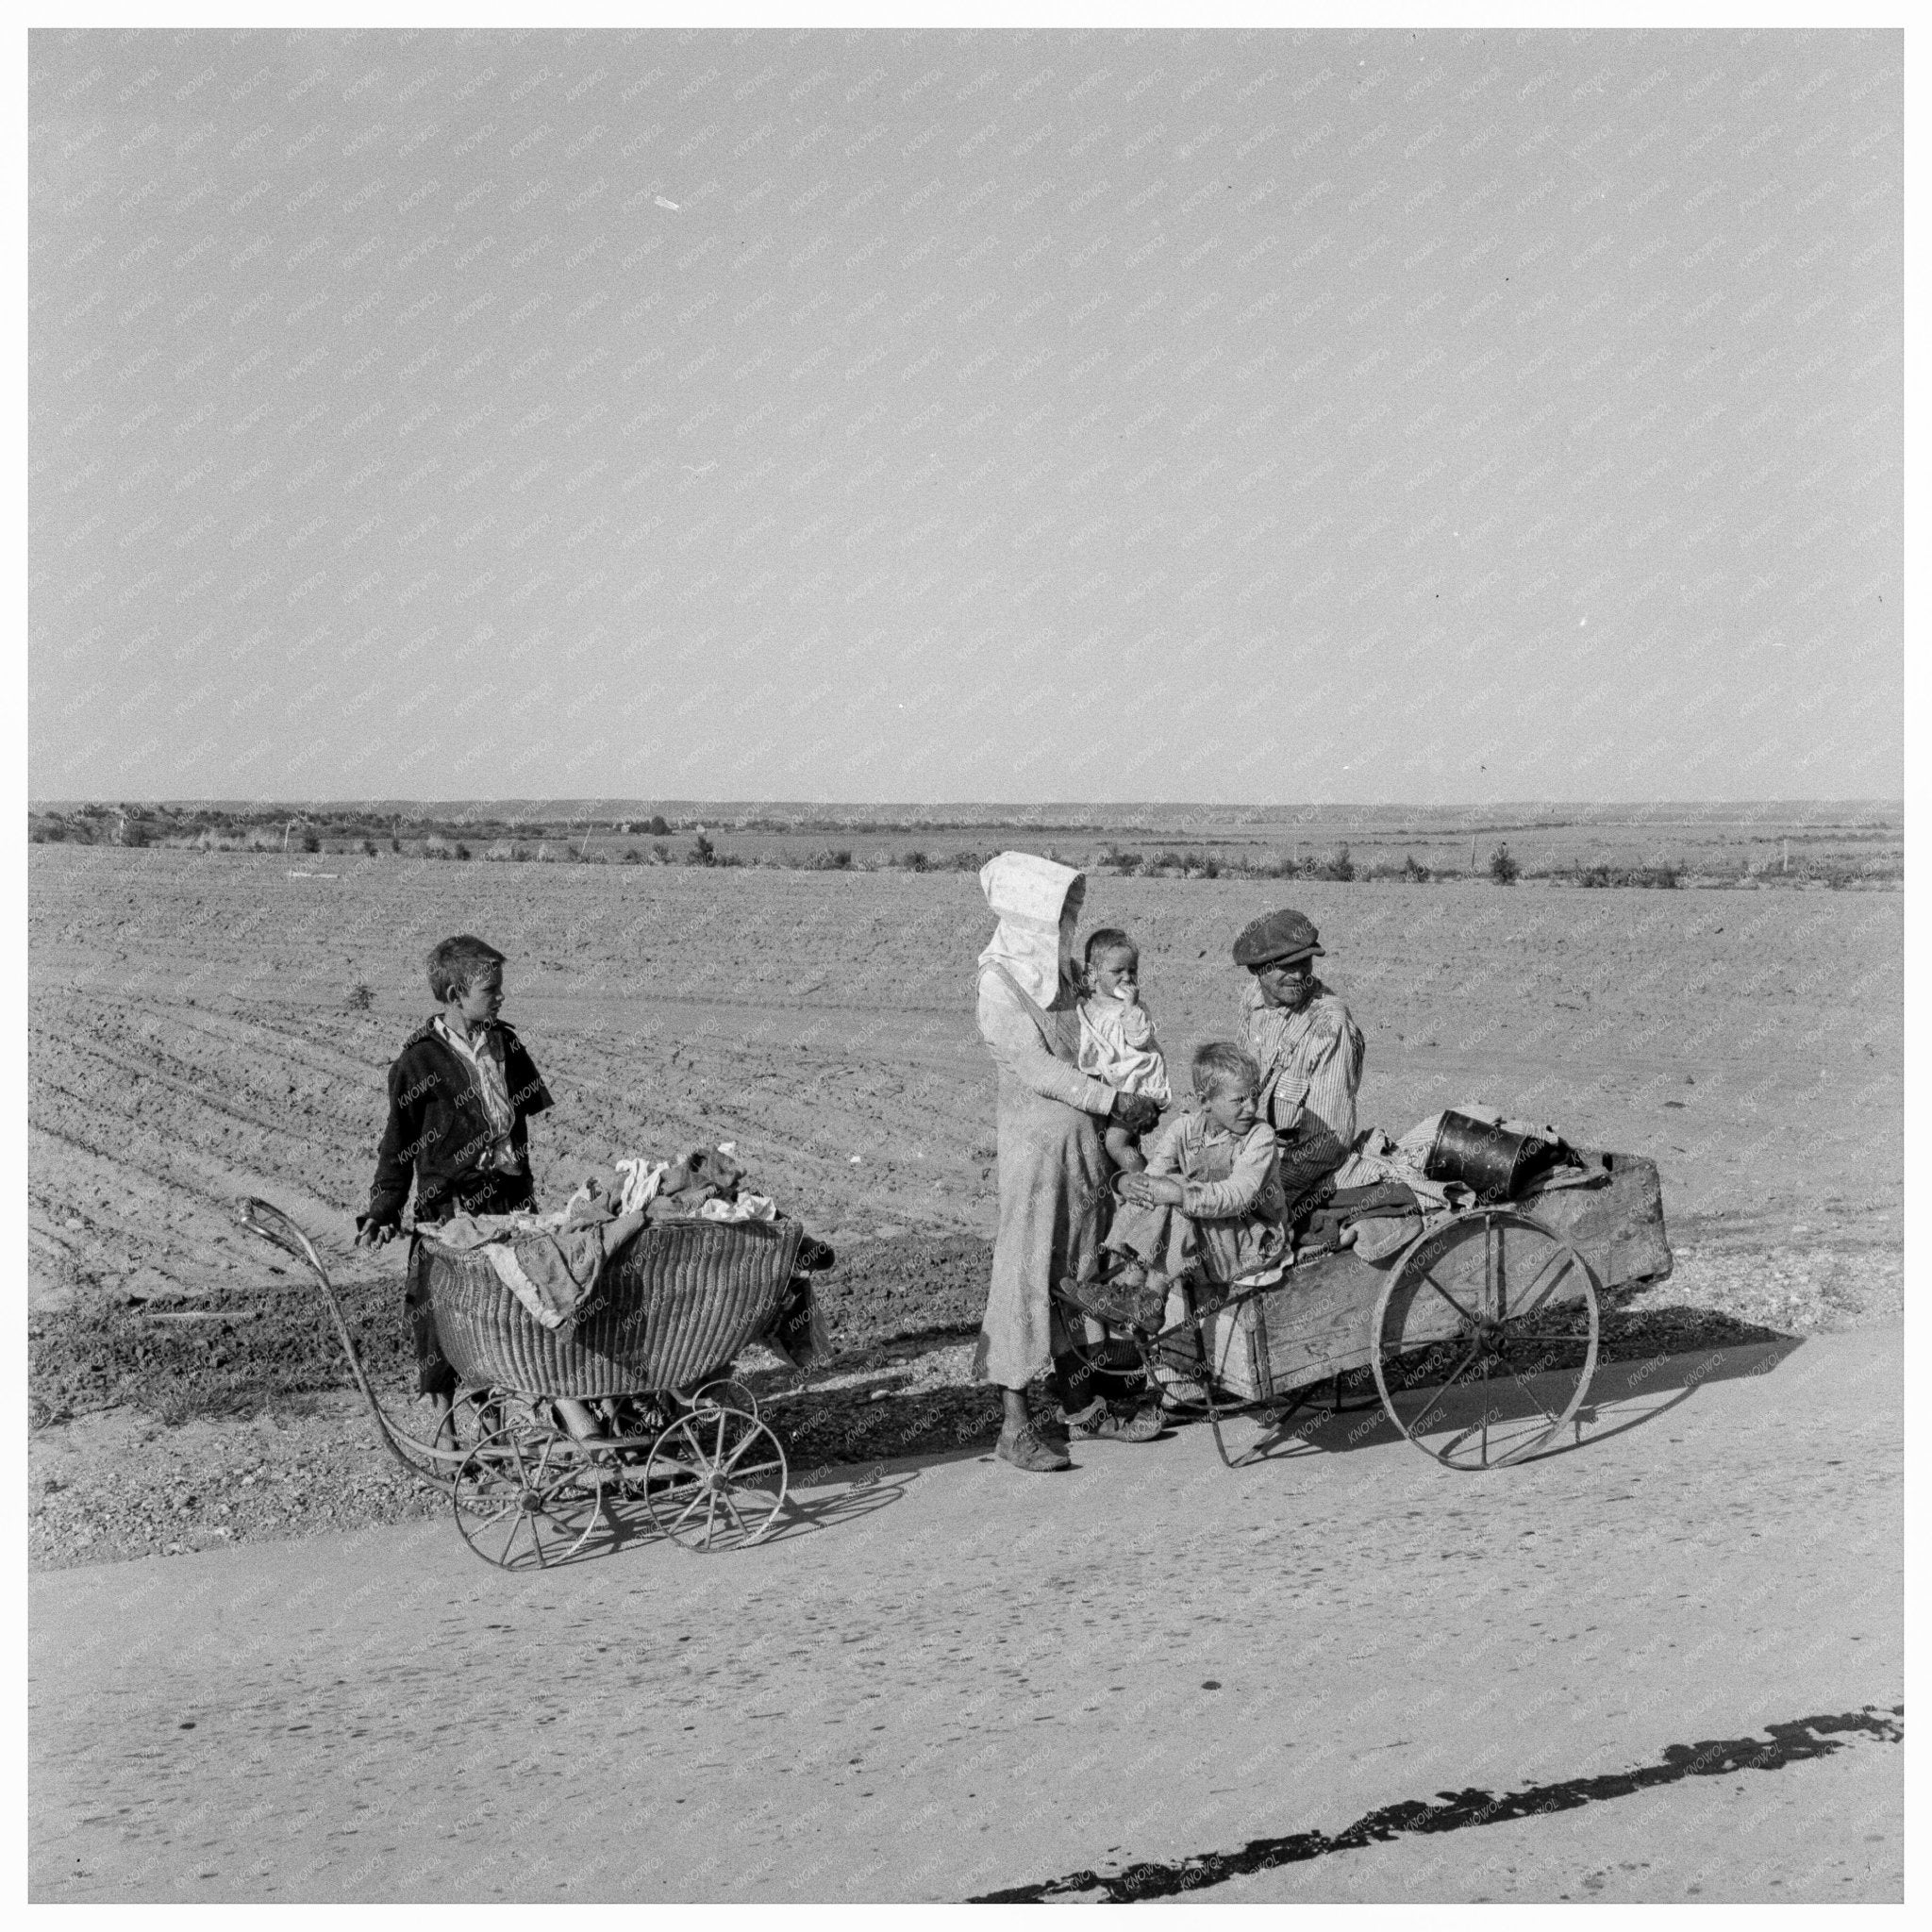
xmin=1206 ymin=1154 xmax=1672 ymax=1403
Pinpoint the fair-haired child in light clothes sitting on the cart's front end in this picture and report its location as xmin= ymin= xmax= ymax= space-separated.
xmin=1069 ymin=1040 xmax=1287 ymax=1329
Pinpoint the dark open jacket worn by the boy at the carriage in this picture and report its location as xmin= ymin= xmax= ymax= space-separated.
xmin=358 ymin=1020 xmax=555 ymax=1226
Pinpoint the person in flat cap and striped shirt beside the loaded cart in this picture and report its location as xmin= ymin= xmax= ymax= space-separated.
xmin=1235 ymin=907 xmax=1366 ymax=1219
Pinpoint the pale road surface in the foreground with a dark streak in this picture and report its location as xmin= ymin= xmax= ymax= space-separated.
xmin=31 ymin=1324 xmax=1903 ymax=1901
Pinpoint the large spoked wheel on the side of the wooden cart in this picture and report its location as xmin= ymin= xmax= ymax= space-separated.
xmin=1370 ymin=1208 xmax=1598 ymax=1471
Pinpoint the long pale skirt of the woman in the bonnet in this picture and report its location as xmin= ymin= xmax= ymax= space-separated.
xmin=974 ymin=1071 xmax=1109 ymax=1390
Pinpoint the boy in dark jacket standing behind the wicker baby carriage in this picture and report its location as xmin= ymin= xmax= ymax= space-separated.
xmin=356 ymin=933 xmax=553 ymax=1408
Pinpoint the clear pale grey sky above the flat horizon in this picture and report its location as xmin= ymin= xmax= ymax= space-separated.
xmin=27 ymin=29 xmax=1903 ymax=804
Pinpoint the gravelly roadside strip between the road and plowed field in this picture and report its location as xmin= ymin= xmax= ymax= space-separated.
xmin=27 ymin=1221 xmax=1903 ymax=1569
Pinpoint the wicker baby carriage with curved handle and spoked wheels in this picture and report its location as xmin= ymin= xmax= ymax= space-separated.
xmin=240 ymin=1200 xmax=809 ymax=1569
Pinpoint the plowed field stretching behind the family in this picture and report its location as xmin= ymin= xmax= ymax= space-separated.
xmin=29 ymin=846 xmax=1903 ymax=1304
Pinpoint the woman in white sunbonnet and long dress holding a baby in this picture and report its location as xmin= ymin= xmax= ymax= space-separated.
xmin=974 ymin=852 xmax=1161 ymax=1471
